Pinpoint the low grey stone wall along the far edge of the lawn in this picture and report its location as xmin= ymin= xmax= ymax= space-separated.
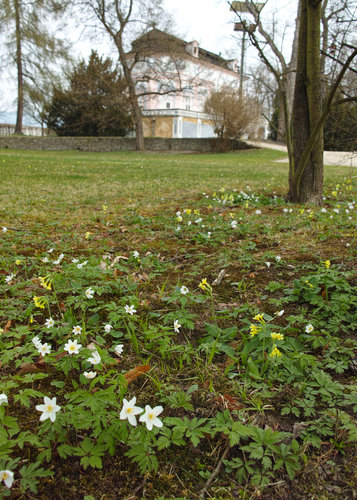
xmin=0 ymin=136 xmax=251 ymax=153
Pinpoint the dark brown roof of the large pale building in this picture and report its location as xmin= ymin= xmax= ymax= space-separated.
xmin=130 ymin=28 xmax=236 ymax=73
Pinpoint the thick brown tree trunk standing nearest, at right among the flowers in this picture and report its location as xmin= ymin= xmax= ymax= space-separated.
xmin=289 ymin=0 xmax=323 ymax=204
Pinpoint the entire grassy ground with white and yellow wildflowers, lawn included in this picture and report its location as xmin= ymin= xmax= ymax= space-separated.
xmin=0 ymin=146 xmax=357 ymax=500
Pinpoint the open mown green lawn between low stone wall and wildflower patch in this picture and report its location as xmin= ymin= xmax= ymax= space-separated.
xmin=0 ymin=150 xmax=348 ymax=224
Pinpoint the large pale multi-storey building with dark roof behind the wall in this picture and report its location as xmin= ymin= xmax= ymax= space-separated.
xmin=128 ymin=29 xmax=240 ymax=137
